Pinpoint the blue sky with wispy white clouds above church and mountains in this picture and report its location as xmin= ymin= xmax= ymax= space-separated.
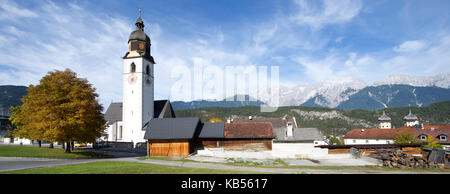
xmin=0 ymin=0 xmax=450 ymax=107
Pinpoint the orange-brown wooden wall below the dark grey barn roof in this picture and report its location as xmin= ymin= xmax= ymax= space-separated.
xmin=147 ymin=139 xmax=191 ymax=157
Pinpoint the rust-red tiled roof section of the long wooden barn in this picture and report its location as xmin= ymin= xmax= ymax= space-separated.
xmin=224 ymin=122 xmax=274 ymax=138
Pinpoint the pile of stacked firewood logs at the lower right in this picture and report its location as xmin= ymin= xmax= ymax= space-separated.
xmin=378 ymin=150 xmax=444 ymax=168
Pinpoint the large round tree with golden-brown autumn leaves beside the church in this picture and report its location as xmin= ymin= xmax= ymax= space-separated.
xmin=10 ymin=69 xmax=106 ymax=152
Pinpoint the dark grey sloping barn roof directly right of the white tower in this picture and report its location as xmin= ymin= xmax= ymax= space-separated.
xmin=144 ymin=117 xmax=200 ymax=139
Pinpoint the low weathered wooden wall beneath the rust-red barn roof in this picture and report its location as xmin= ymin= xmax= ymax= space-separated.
xmin=194 ymin=139 xmax=272 ymax=151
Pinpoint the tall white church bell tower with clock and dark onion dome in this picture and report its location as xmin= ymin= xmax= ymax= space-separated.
xmin=122 ymin=10 xmax=155 ymax=146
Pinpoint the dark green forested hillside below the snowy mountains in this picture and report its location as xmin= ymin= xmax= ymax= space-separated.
xmin=175 ymin=101 xmax=450 ymax=135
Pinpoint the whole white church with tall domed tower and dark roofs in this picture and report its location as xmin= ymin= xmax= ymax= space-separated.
xmin=103 ymin=12 xmax=175 ymax=147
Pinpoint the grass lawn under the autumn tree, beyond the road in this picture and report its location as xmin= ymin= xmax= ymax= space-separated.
xmin=0 ymin=145 xmax=111 ymax=159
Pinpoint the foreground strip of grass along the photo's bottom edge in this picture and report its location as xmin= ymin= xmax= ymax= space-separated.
xmin=0 ymin=161 xmax=254 ymax=174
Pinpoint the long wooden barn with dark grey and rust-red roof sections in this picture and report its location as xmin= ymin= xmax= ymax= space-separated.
xmin=145 ymin=118 xmax=274 ymax=157
